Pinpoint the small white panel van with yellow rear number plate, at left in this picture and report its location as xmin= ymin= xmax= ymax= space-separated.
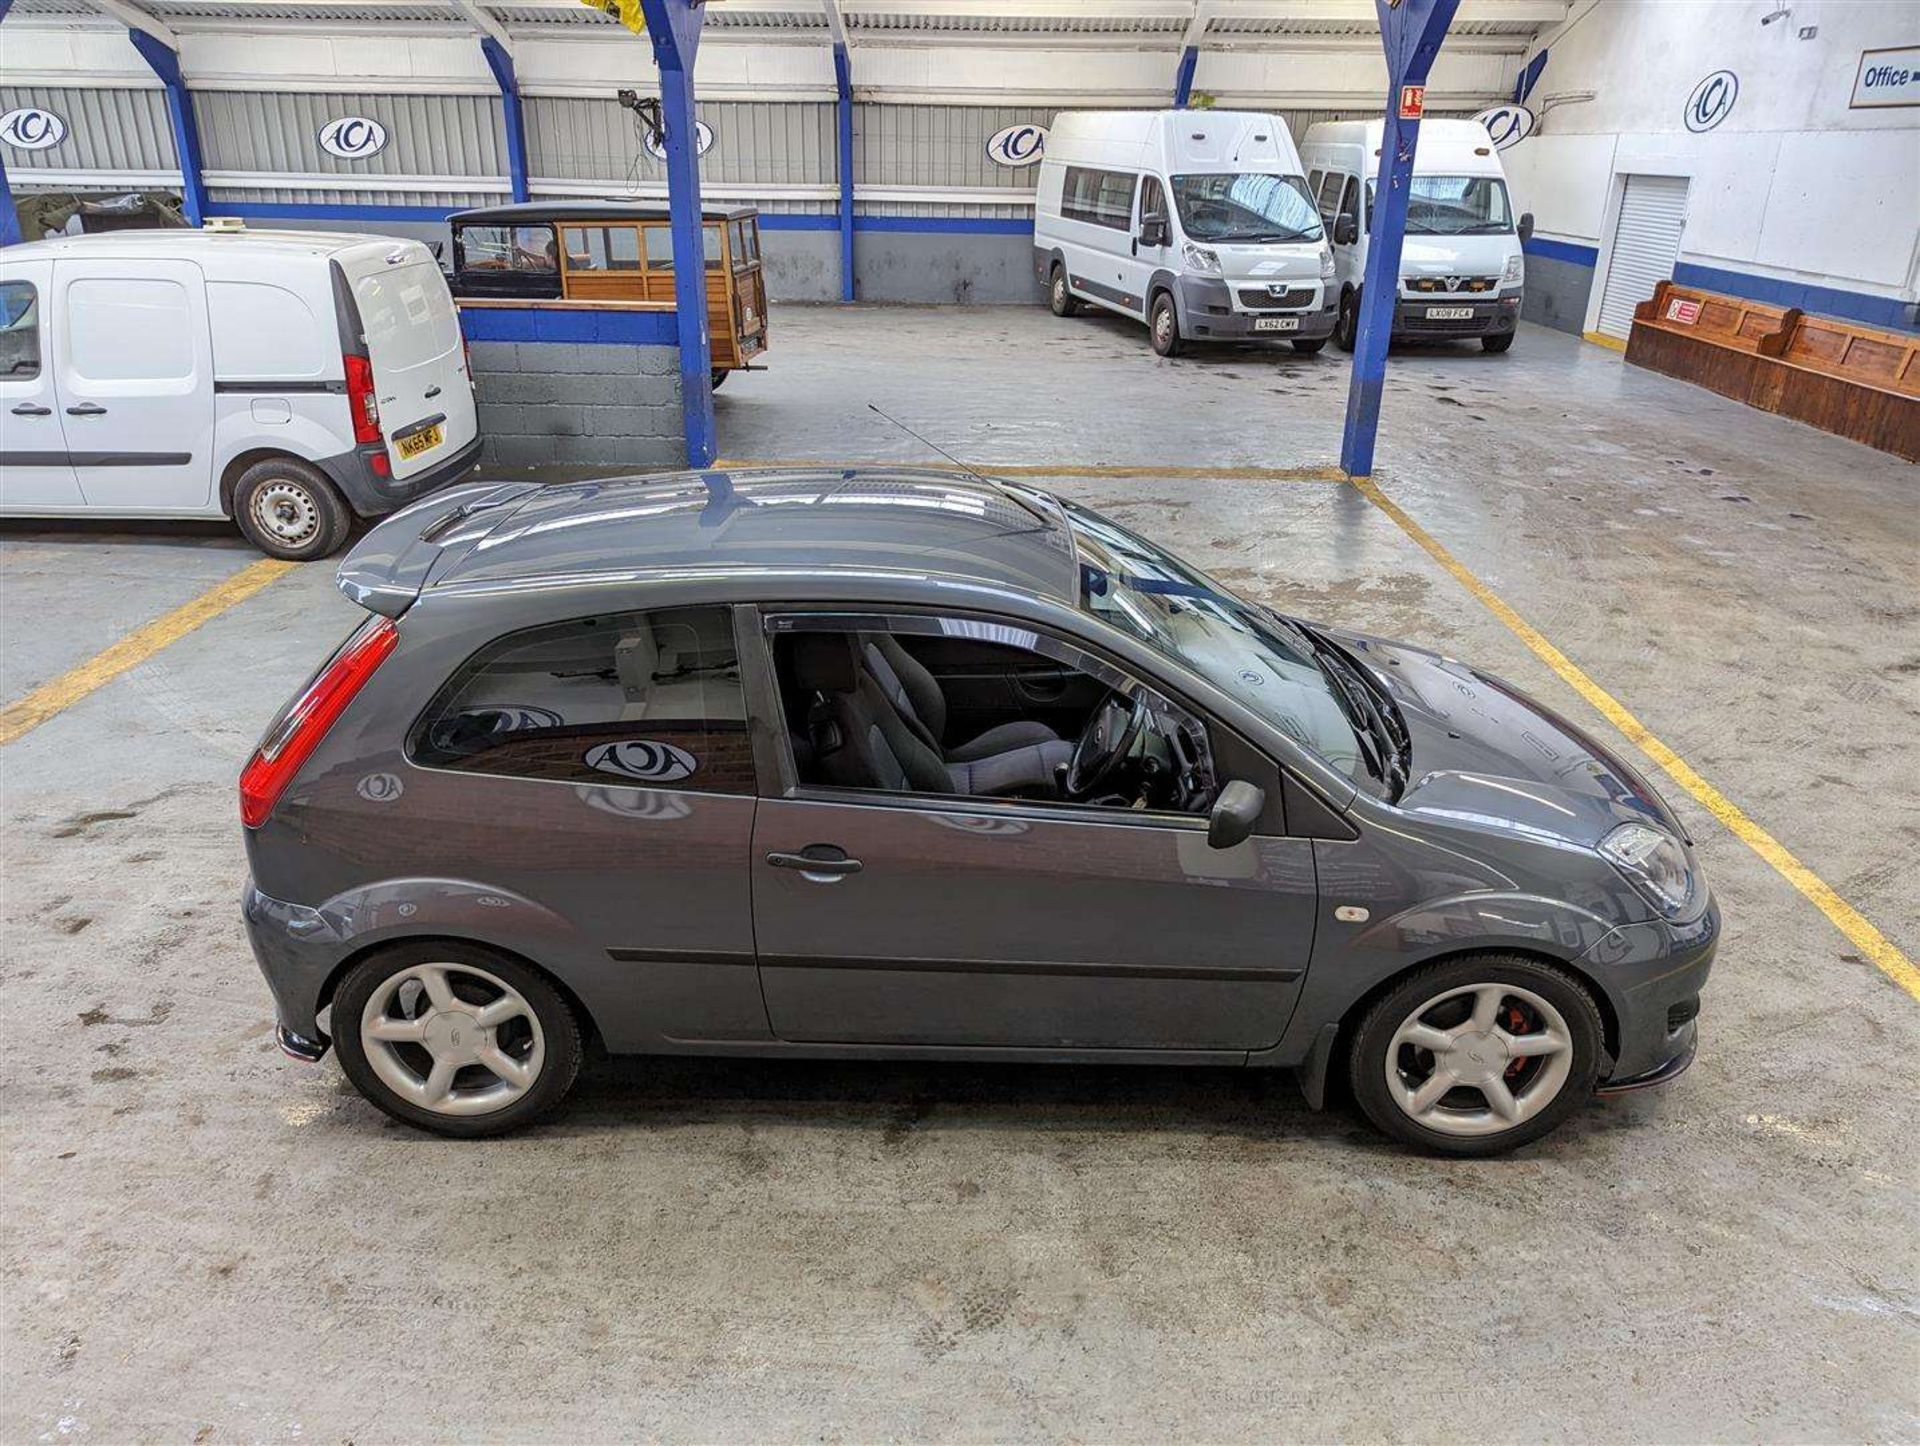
xmin=0 ymin=223 xmax=480 ymax=559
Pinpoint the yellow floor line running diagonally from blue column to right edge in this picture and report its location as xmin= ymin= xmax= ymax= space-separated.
xmin=1354 ymin=476 xmax=1920 ymax=1000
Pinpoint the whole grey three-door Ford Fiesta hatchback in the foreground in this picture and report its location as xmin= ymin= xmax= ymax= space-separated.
xmin=240 ymin=470 xmax=1718 ymax=1154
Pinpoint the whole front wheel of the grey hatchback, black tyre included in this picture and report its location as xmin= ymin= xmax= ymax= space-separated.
xmin=1348 ymin=954 xmax=1605 ymax=1156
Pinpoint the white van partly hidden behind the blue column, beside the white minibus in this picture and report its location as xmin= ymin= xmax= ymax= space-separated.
xmin=1300 ymin=121 xmax=1534 ymax=351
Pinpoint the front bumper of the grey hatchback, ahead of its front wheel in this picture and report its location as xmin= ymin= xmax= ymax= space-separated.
xmin=1580 ymin=899 xmax=1720 ymax=1095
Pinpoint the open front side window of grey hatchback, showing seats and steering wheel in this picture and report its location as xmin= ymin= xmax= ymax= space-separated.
xmin=772 ymin=616 xmax=1215 ymax=814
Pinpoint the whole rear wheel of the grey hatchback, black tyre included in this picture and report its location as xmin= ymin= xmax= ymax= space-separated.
xmin=332 ymin=941 xmax=582 ymax=1139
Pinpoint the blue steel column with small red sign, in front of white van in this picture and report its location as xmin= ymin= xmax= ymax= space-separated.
xmin=1340 ymin=0 xmax=1459 ymax=476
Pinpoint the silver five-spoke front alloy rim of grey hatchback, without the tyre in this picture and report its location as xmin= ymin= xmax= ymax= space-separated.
xmin=1386 ymin=983 xmax=1572 ymax=1135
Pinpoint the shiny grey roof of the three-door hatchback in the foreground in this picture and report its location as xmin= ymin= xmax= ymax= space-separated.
xmin=432 ymin=467 xmax=1077 ymax=601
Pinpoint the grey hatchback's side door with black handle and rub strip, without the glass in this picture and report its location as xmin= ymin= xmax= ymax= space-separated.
xmin=753 ymin=618 xmax=1317 ymax=1050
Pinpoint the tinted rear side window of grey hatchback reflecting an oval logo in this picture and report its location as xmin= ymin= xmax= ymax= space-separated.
xmin=411 ymin=607 xmax=755 ymax=793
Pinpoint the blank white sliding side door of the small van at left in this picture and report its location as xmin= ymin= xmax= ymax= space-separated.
xmin=54 ymin=259 xmax=213 ymax=517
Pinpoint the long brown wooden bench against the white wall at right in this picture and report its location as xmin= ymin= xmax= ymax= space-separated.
xmin=1626 ymin=280 xmax=1920 ymax=461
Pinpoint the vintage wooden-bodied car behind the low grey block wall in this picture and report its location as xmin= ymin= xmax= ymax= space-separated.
xmin=447 ymin=202 xmax=766 ymax=386
